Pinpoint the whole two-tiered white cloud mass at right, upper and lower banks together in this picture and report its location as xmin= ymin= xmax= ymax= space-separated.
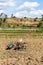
xmin=15 ymin=2 xmax=43 ymax=17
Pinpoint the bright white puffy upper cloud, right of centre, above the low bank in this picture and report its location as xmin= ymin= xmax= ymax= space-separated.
xmin=18 ymin=2 xmax=40 ymax=10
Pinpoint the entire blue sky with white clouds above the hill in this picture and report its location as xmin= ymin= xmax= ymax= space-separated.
xmin=0 ymin=0 xmax=43 ymax=18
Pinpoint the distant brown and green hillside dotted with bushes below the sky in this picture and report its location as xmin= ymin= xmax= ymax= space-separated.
xmin=0 ymin=18 xmax=41 ymax=28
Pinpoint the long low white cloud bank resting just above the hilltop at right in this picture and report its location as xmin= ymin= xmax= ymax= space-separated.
xmin=15 ymin=10 xmax=43 ymax=18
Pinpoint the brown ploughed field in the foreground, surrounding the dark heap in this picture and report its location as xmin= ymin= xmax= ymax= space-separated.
xmin=0 ymin=31 xmax=43 ymax=65
